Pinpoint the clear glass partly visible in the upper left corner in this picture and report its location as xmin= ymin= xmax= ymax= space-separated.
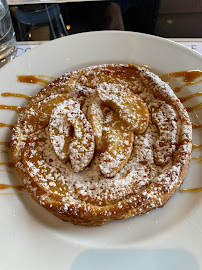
xmin=0 ymin=0 xmax=17 ymax=67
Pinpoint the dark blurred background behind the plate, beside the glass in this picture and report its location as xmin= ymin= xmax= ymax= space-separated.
xmin=8 ymin=0 xmax=202 ymax=41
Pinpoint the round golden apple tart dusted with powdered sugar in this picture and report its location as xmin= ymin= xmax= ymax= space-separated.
xmin=12 ymin=64 xmax=192 ymax=226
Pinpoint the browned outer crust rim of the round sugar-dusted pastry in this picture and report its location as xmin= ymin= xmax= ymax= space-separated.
xmin=11 ymin=65 xmax=192 ymax=226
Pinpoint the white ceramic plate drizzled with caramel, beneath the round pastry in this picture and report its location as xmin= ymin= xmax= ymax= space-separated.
xmin=0 ymin=31 xmax=202 ymax=270
